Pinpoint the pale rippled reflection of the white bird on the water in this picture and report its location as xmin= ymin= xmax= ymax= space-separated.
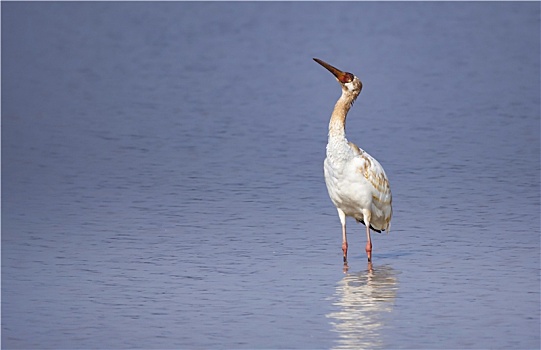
xmin=327 ymin=263 xmax=398 ymax=349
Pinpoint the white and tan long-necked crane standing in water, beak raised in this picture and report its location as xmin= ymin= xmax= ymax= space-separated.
xmin=314 ymin=58 xmax=393 ymax=268
